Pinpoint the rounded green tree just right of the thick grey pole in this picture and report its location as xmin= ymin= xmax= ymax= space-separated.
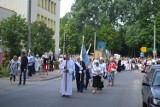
xmin=31 ymin=22 xmax=55 ymax=55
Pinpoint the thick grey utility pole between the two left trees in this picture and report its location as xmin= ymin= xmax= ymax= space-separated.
xmin=27 ymin=0 xmax=31 ymax=52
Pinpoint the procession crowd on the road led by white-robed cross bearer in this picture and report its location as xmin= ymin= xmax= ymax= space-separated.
xmin=59 ymin=55 xmax=160 ymax=97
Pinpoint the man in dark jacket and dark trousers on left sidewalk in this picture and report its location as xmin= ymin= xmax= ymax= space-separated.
xmin=19 ymin=52 xmax=28 ymax=85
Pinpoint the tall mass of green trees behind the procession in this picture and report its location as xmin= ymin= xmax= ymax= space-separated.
xmin=61 ymin=0 xmax=160 ymax=56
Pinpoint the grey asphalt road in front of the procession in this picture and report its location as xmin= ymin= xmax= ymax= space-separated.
xmin=0 ymin=71 xmax=142 ymax=107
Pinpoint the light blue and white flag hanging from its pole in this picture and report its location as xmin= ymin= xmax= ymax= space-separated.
xmin=80 ymin=43 xmax=89 ymax=66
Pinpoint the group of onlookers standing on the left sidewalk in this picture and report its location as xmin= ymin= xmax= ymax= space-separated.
xmin=8 ymin=52 xmax=56 ymax=85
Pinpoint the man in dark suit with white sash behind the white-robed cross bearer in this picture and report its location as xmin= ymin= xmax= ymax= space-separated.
xmin=75 ymin=57 xmax=86 ymax=93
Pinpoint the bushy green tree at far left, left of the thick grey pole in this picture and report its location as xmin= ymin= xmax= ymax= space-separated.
xmin=0 ymin=15 xmax=27 ymax=58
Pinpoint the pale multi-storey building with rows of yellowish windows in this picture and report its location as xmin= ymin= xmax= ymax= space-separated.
xmin=0 ymin=0 xmax=60 ymax=54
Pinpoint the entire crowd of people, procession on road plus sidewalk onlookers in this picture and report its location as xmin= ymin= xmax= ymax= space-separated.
xmin=8 ymin=52 xmax=160 ymax=97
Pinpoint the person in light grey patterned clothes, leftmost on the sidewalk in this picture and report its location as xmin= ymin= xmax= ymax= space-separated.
xmin=9 ymin=55 xmax=18 ymax=84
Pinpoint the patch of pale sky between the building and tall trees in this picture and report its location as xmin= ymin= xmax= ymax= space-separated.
xmin=60 ymin=0 xmax=75 ymax=18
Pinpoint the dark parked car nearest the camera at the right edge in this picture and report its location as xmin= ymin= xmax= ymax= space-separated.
xmin=142 ymin=68 xmax=160 ymax=107
